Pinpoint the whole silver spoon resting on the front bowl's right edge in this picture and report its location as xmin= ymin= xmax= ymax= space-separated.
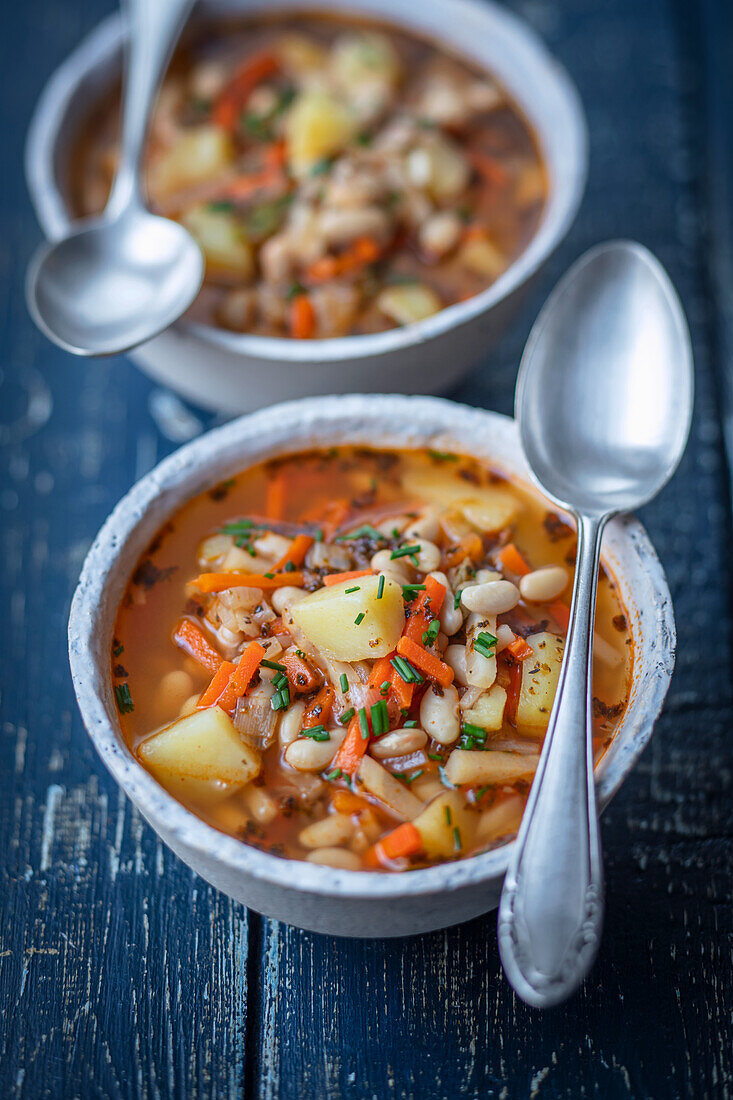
xmin=499 ymin=241 xmax=693 ymax=1008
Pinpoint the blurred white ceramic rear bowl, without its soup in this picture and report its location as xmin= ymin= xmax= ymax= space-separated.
xmin=25 ymin=0 xmax=588 ymax=414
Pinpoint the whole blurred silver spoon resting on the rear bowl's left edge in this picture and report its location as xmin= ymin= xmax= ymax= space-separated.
xmin=26 ymin=0 xmax=204 ymax=355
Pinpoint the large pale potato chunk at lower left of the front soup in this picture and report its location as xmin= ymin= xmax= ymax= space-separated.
xmin=138 ymin=706 xmax=261 ymax=793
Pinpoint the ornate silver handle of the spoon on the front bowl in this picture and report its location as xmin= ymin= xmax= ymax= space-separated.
xmin=499 ymin=516 xmax=608 ymax=1008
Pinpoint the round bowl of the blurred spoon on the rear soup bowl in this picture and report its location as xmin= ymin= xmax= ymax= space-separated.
xmin=28 ymin=207 xmax=204 ymax=355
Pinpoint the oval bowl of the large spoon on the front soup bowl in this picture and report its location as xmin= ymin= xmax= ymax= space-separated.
xmin=516 ymin=241 xmax=692 ymax=515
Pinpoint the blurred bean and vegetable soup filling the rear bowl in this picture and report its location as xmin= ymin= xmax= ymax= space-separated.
xmin=69 ymin=13 xmax=547 ymax=339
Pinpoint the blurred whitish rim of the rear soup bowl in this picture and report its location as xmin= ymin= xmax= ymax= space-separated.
xmin=24 ymin=0 xmax=589 ymax=366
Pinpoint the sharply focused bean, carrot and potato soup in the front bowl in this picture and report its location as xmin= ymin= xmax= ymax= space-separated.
xmin=111 ymin=448 xmax=633 ymax=871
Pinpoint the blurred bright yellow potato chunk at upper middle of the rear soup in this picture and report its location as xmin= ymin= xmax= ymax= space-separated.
xmin=285 ymin=88 xmax=355 ymax=176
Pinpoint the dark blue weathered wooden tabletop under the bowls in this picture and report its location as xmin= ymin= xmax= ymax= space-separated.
xmin=0 ymin=0 xmax=733 ymax=1100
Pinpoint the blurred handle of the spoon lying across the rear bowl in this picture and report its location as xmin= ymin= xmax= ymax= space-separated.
xmin=107 ymin=0 xmax=194 ymax=216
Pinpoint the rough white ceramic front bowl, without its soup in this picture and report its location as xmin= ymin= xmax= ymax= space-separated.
xmin=69 ymin=395 xmax=675 ymax=936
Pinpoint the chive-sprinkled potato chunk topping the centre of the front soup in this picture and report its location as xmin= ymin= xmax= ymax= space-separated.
xmin=291 ymin=576 xmax=405 ymax=661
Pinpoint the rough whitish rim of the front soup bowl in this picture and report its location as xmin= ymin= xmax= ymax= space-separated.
xmin=68 ymin=395 xmax=676 ymax=901
